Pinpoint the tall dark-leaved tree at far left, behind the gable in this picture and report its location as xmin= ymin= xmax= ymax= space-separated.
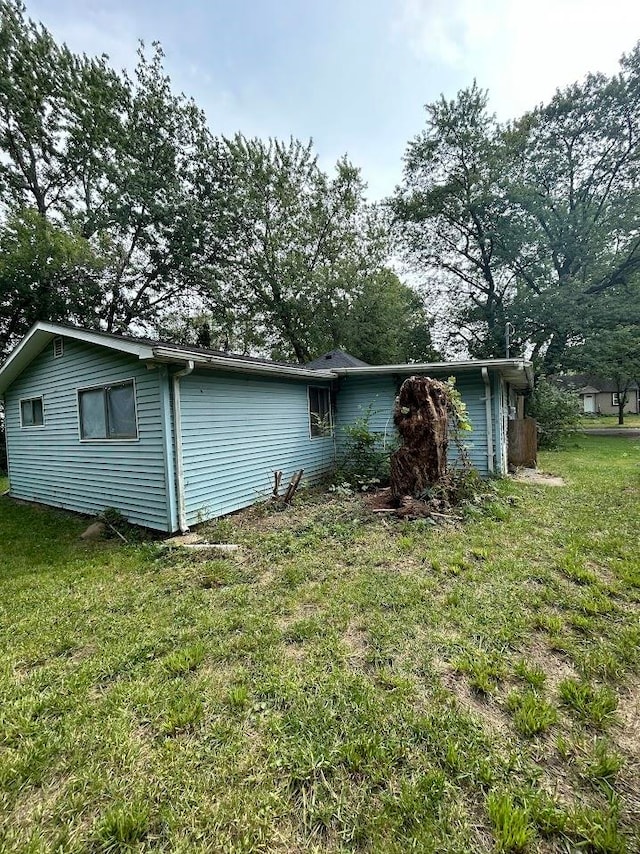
xmin=0 ymin=0 xmax=225 ymax=354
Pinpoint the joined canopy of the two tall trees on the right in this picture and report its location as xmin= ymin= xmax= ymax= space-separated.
xmin=391 ymin=47 xmax=640 ymax=372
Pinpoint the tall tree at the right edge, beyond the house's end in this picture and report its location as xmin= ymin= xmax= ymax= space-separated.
xmin=505 ymin=47 xmax=640 ymax=371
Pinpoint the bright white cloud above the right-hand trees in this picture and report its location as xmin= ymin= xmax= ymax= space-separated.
xmin=397 ymin=0 xmax=640 ymax=118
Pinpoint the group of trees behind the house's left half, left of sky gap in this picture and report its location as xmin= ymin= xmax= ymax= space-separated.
xmin=0 ymin=0 xmax=430 ymax=361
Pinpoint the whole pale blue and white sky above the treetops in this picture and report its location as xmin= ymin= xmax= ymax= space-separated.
xmin=27 ymin=0 xmax=640 ymax=198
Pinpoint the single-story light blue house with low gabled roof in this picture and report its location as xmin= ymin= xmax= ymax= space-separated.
xmin=0 ymin=323 xmax=532 ymax=531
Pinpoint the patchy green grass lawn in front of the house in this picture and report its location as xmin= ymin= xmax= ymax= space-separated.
xmin=0 ymin=436 xmax=640 ymax=854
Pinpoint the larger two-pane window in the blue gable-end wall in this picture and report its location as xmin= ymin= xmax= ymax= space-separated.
xmin=78 ymin=380 xmax=138 ymax=439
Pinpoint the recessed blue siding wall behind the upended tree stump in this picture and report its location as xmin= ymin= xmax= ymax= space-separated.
xmin=336 ymin=370 xmax=506 ymax=477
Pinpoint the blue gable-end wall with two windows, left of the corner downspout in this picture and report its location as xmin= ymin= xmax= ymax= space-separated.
xmin=5 ymin=338 xmax=174 ymax=530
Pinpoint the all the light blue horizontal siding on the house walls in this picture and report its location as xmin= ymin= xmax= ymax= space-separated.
xmin=5 ymin=330 xmax=506 ymax=531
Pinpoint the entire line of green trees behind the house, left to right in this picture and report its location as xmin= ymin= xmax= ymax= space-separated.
xmin=0 ymin=0 xmax=640 ymax=373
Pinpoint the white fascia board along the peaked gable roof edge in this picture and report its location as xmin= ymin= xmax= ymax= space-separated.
xmin=0 ymin=321 xmax=153 ymax=394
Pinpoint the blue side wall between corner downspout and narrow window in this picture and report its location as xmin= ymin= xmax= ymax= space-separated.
xmin=180 ymin=371 xmax=335 ymax=525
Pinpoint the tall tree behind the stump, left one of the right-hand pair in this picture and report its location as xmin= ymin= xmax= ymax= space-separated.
xmin=391 ymin=83 xmax=512 ymax=356
